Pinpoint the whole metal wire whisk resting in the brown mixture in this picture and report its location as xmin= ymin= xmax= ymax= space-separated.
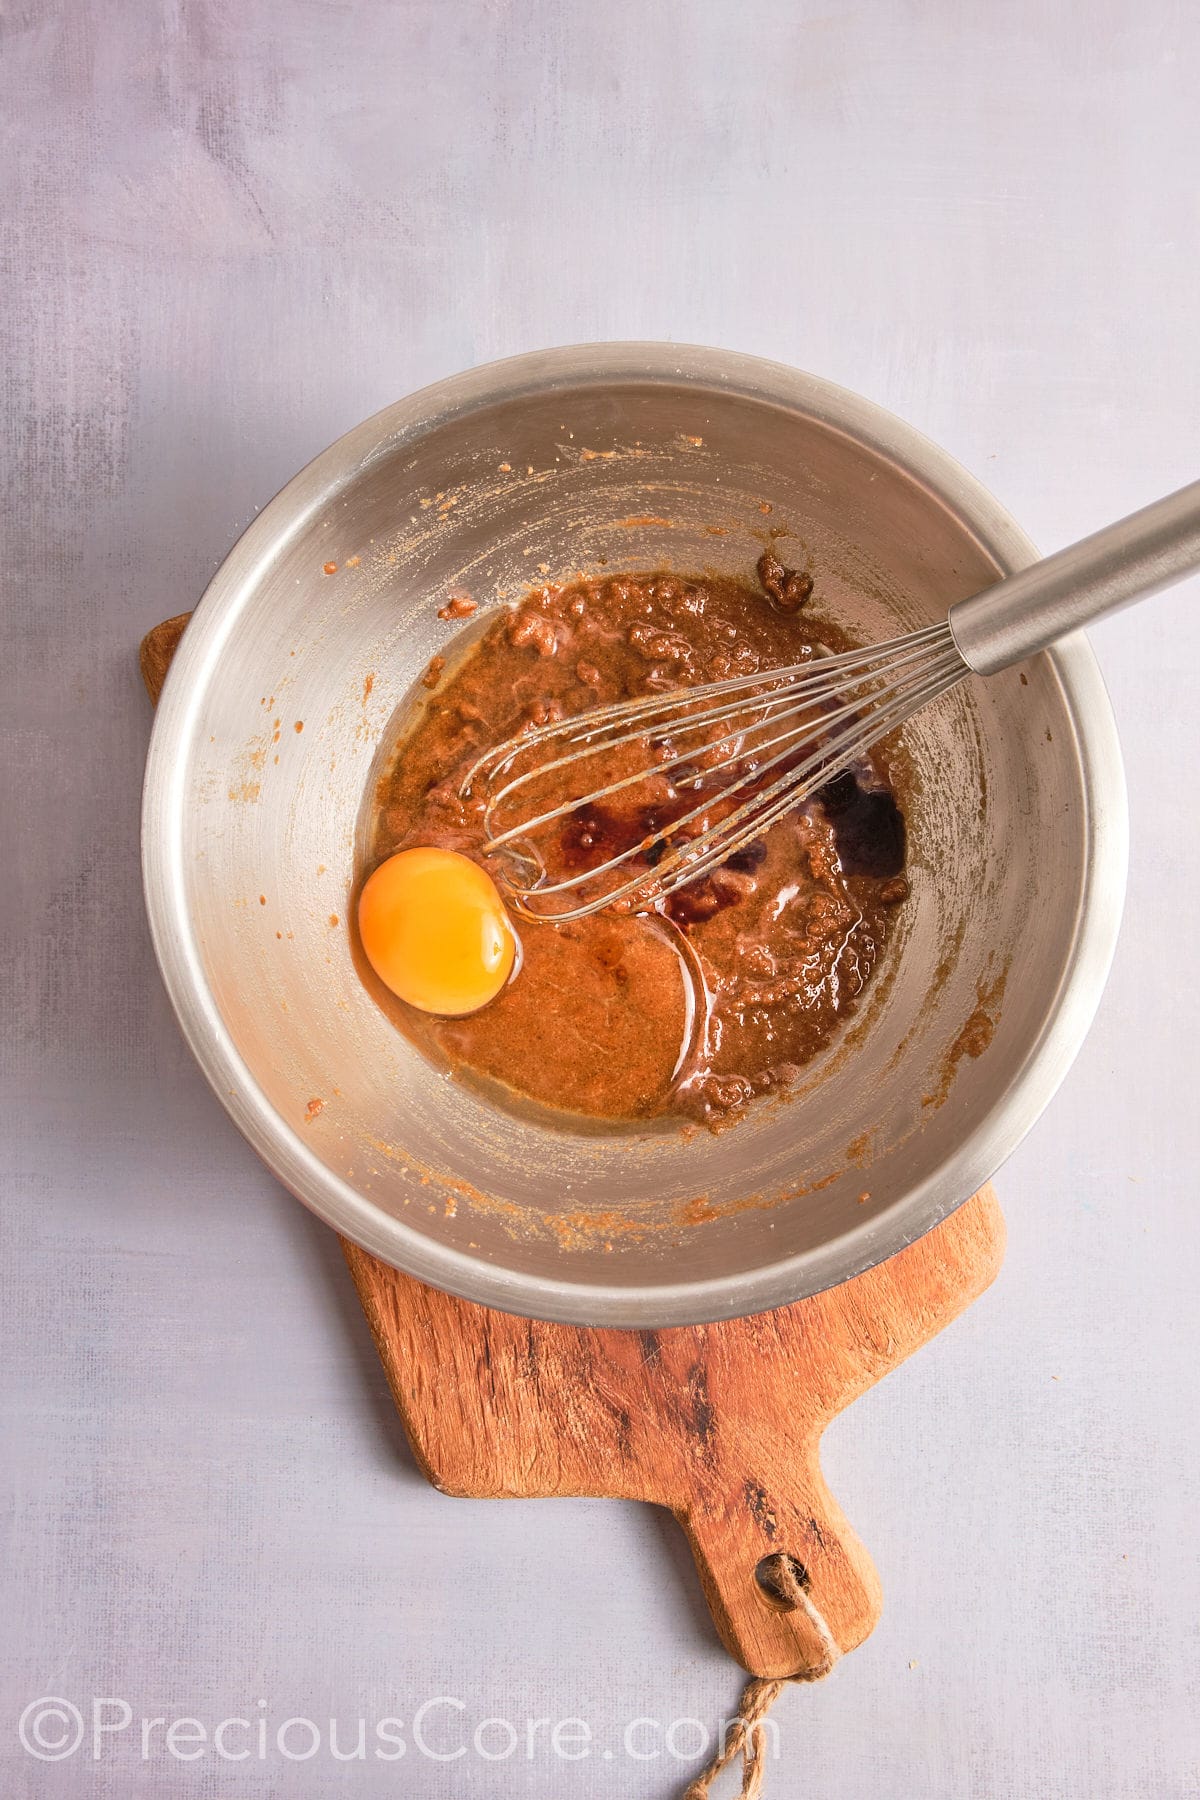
xmin=462 ymin=482 xmax=1200 ymax=922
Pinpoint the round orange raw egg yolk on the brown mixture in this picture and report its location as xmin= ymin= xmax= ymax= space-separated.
xmin=358 ymin=848 xmax=516 ymax=1017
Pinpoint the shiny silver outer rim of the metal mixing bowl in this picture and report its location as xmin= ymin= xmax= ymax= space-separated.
xmin=142 ymin=342 xmax=1128 ymax=1328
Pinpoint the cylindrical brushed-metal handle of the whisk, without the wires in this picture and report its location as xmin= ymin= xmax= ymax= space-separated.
xmin=950 ymin=481 xmax=1200 ymax=675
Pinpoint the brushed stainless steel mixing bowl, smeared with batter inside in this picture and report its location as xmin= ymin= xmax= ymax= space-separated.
xmin=144 ymin=344 xmax=1126 ymax=1325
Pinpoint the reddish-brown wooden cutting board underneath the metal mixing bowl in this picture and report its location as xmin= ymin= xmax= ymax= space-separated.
xmin=140 ymin=614 xmax=1004 ymax=1678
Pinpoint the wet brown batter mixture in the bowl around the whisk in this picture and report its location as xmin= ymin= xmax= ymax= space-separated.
xmin=369 ymin=553 xmax=907 ymax=1125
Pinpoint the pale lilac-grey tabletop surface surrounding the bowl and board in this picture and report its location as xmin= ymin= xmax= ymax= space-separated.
xmin=0 ymin=0 xmax=1200 ymax=1800
